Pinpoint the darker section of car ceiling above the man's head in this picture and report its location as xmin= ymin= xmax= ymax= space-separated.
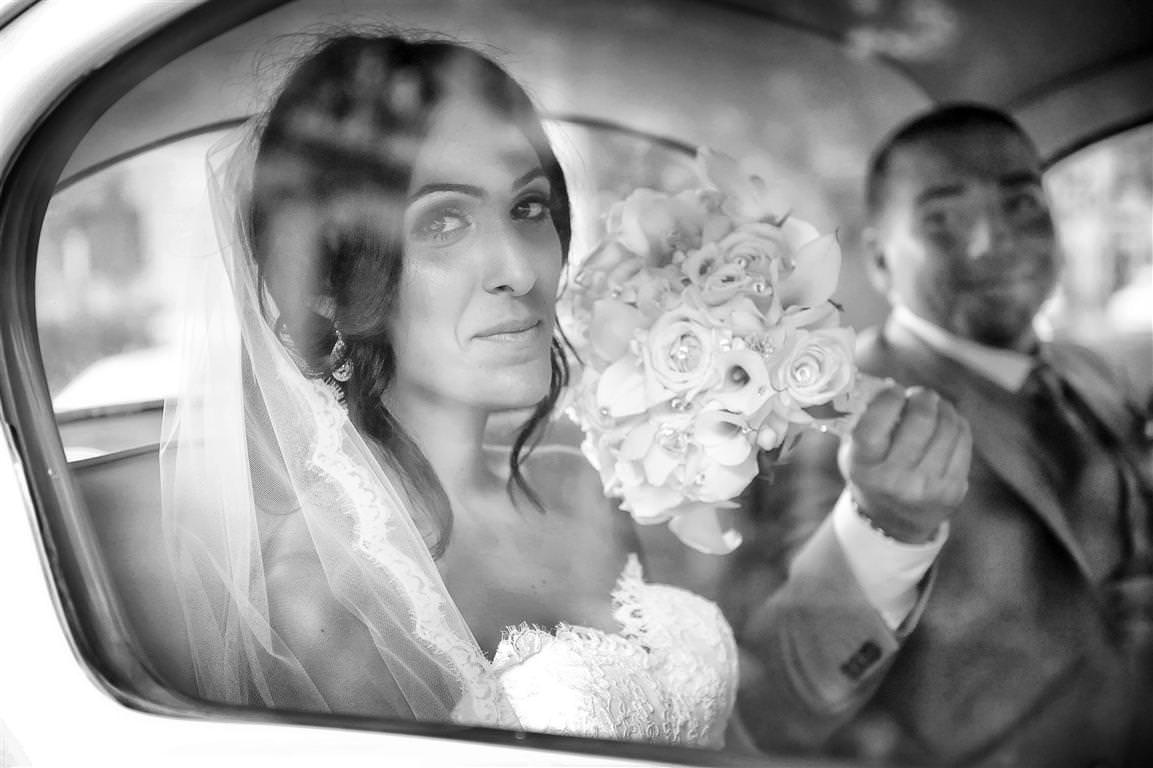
xmin=719 ymin=0 xmax=1153 ymax=160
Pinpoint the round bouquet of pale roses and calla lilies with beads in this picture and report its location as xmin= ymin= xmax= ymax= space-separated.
xmin=562 ymin=150 xmax=857 ymax=554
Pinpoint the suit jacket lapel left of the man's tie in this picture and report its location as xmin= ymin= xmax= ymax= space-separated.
xmin=884 ymin=322 xmax=1092 ymax=580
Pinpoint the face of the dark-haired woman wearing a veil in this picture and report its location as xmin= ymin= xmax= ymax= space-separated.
xmin=391 ymin=93 xmax=562 ymax=411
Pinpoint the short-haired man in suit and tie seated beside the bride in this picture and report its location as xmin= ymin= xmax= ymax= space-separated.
xmin=743 ymin=105 xmax=1153 ymax=766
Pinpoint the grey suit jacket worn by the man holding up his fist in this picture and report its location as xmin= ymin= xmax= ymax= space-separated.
xmin=744 ymin=313 xmax=1153 ymax=766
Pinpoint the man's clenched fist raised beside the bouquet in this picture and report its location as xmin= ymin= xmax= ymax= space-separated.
xmin=837 ymin=384 xmax=972 ymax=544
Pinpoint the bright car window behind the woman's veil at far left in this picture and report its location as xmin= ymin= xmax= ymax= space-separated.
xmin=36 ymin=133 xmax=227 ymax=459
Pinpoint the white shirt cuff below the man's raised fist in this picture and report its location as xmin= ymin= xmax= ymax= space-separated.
xmin=832 ymin=488 xmax=949 ymax=630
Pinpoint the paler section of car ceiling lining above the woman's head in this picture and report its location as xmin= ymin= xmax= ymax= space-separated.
xmin=58 ymin=0 xmax=927 ymax=178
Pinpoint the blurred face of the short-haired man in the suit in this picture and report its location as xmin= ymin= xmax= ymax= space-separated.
xmin=874 ymin=126 xmax=1058 ymax=348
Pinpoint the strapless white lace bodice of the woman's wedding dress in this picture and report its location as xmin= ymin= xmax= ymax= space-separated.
xmin=492 ymin=556 xmax=737 ymax=748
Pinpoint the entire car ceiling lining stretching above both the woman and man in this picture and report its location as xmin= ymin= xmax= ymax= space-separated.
xmin=65 ymin=0 xmax=1153 ymax=184
